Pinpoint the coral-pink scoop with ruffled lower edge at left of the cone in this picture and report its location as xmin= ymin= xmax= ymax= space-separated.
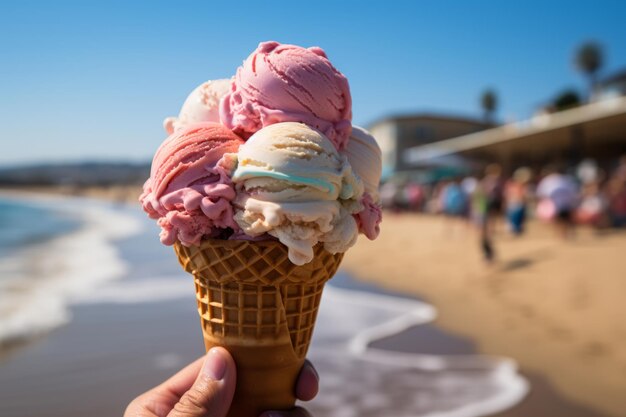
xmin=139 ymin=122 xmax=243 ymax=246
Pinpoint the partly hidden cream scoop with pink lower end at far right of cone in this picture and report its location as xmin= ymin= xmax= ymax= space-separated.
xmin=343 ymin=126 xmax=382 ymax=240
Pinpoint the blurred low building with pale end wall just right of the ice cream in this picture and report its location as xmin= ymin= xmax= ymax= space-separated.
xmin=368 ymin=113 xmax=493 ymax=178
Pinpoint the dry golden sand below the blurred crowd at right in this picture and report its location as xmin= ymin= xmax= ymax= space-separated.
xmin=343 ymin=213 xmax=626 ymax=416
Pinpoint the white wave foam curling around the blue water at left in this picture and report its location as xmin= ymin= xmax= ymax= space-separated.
xmin=0 ymin=194 xmax=141 ymax=346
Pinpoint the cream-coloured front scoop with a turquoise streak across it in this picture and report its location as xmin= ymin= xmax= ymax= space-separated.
xmin=232 ymin=122 xmax=363 ymax=265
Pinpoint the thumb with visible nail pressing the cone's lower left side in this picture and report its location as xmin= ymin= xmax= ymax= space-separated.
xmin=168 ymin=347 xmax=236 ymax=417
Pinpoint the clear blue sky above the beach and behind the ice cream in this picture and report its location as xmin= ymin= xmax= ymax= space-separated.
xmin=0 ymin=0 xmax=626 ymax=166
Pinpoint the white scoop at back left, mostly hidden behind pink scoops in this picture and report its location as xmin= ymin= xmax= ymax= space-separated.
xmin=163 ymin=79 xmax=231 ymax=135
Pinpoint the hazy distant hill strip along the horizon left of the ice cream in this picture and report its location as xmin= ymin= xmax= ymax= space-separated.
xmin=0 ymin=162 xmax=150 ymax=186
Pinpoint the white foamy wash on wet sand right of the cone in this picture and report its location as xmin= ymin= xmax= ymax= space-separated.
xmin=309 ymin=286 xmax=529 ymax=417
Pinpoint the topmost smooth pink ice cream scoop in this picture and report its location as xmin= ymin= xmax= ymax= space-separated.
xmin=220 ymin=42 xmax=352 ymax=150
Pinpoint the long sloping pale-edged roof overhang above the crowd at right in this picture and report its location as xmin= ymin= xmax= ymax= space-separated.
xmin=402 ymin=78 xmax=626 ymax=170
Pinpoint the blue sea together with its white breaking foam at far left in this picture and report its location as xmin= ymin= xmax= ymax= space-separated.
xmin=0 ymin=194 xmax=138 ymax=347
